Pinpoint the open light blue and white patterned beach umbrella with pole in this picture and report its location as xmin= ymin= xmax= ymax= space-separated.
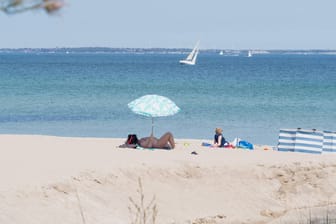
xmin=128 ymin=95 xmax=180 ymax=134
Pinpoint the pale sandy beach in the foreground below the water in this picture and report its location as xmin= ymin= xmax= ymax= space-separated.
xmin=0 ymin=135 xmax=336 ymax=224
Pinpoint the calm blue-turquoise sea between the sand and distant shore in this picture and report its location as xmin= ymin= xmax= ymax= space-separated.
xmin=0 ymin=49 xmax=336 ymax=146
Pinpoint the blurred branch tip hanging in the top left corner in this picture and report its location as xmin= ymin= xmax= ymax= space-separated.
xmin=0 ymin=0 xmax=64 ymax=14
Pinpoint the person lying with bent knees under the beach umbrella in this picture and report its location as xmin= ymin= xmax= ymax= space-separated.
xmin=123 ymin=132 xmax=175 ymax=149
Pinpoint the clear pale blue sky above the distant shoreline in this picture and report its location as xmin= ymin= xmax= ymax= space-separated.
xmin=0 ymin=0 xmax=336 ymax=50
